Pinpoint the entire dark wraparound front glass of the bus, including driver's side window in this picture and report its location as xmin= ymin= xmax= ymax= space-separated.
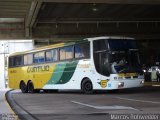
xmin=93 ymin=39 xmax=141 ymax=76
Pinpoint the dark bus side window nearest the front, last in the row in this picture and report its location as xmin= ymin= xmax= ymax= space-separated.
xmin=75 ymin=44 xmax=90 ymax=58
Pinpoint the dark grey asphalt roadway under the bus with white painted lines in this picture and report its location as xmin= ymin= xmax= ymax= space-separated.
xmin=6 ymin=86 xmax=160 ymax=120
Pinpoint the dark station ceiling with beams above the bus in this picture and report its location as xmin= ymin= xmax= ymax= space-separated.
xmin=0 ymin=0 xmax=160 ymax=39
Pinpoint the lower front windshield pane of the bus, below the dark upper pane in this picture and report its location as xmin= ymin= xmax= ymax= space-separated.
xmin=109 ymin=50 xmax=141 ymax=74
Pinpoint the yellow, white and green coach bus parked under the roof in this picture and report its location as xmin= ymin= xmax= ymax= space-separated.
xmin=9 ymin=37 xmax=144 ymax=93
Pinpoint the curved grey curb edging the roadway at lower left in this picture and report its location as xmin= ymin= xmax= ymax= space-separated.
xmin=5 ymin=90 xmax=38 ymax=120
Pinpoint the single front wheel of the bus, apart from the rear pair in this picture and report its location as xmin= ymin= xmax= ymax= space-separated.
xmin=81 ymin=78 xmax=93 ymax=94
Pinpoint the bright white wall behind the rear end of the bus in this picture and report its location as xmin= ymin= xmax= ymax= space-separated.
xmin=0 ymin=40 xmax=34 ymax=89
